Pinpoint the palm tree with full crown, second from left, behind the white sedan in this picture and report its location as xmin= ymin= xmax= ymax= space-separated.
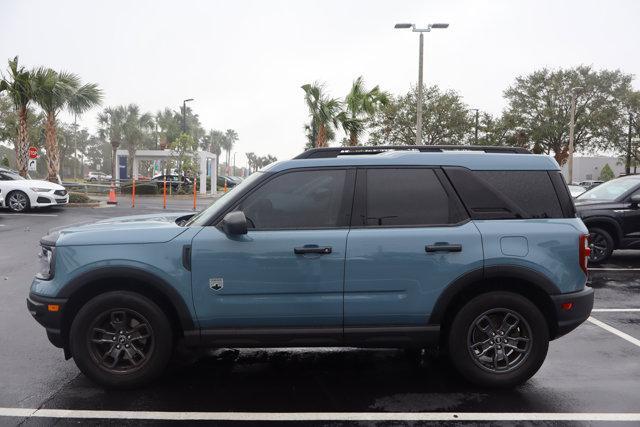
xmin=34 ymin=68 xmax=102 ymax=182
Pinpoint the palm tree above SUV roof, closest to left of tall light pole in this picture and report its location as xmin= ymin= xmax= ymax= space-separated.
xmin=339 ymin=76 xmax=389 ymax=146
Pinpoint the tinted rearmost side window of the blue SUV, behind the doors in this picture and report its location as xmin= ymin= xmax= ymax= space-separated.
xmin=475 ymin=171 xmax=563 ymax=218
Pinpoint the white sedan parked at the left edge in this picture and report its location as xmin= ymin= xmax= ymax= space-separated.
xmin=0 ymin=168 xmax=69 ymax=212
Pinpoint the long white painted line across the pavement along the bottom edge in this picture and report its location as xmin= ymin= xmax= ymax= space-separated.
xmin=0 ymin=408 xmax=640 ymax=422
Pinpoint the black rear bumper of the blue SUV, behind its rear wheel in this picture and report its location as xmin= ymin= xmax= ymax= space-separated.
xmin=551 ymin=286 xmax=594 ymax=338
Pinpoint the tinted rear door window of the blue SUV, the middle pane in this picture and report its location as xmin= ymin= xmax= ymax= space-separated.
xmin=365 ymin=169 xmax=461 ymax=226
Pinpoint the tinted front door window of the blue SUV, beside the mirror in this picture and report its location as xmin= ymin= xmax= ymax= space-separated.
xmin=239 ymin=170 xmax=347 ymax=230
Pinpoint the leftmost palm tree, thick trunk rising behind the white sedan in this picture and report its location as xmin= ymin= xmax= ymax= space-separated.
xmin=0 ymin=56 xmax=33 ymax=177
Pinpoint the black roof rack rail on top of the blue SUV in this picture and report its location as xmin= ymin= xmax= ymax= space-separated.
xmin=294 ymin=145 xmax=531 ymax=159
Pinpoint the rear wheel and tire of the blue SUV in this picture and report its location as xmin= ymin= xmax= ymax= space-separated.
xmin=448 ymin=292 xmax=549 ymax=388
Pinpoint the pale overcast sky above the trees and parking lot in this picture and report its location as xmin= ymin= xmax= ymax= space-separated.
xmin=0 ymin=0 xmax=640 ymax=164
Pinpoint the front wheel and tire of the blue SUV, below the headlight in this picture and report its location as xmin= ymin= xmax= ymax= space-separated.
xmin=69 ymin=291 xmax=173 ymax=389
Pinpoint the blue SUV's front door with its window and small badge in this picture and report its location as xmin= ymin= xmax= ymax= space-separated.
xmin=192 ymin=169 xmax=355 ymax=345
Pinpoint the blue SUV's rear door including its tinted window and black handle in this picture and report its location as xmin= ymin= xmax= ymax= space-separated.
xmin=344 ymin=167 xmax=483 ymax=344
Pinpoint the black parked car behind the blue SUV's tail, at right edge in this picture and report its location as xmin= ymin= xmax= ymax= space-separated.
xmin=575 ymin=175 xmax=640 ymax=263
